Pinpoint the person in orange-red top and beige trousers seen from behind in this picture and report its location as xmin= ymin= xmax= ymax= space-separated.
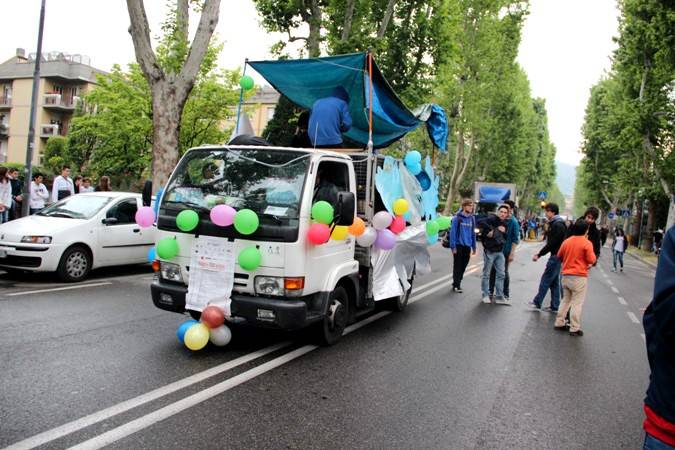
xmin=554 ymin=219 xmax=596 ymax=336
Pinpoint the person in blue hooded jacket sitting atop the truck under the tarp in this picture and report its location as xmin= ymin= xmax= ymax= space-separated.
xmin=307 ymin=86 xmax=352 ymax=148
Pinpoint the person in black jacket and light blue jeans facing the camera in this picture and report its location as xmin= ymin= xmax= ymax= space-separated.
xmin=479 ymin=205 xmax=509 ymax=305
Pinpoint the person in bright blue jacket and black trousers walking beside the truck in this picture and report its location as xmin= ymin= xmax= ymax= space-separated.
xmin=448 ymin=198 xmax=476 ymax=293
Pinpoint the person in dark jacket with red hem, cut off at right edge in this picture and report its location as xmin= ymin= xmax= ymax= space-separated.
xmin=642 ymin=227 xmax=675 ymax=450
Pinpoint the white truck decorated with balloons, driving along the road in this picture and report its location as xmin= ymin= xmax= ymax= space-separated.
xmin=151 ymin=145 xmax=429 ymax=344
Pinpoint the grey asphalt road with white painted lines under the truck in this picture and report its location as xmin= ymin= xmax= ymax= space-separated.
xmin=0 ymin=243 xmax=654 ymax=449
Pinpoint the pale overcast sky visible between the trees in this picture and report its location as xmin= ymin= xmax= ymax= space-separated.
xmin=0 ymin=0 xmax=618 ymax=165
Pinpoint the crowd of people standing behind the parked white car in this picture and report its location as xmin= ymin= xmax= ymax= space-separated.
xmin=0 ymin=166 xmax=112 ymax=224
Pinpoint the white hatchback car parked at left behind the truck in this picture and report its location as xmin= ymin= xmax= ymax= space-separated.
xmin=0 ymin=192 xmax=155 ymax=281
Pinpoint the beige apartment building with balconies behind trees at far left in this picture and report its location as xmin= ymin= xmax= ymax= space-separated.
xmin=0 ymin=49 xmax=105 ymax=164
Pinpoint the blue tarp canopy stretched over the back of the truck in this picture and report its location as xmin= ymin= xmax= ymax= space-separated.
xmin=248 ymin=53 xmax=448 ymax=151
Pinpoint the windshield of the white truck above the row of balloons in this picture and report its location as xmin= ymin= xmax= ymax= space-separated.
xmin=162 ymin=148 xmax=309 ymax=224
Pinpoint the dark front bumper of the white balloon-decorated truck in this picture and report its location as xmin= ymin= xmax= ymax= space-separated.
xmin=150 ymin=279 xmax=323 ymax=330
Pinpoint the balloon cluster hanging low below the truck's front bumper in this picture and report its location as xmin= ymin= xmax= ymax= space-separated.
xmin=176 ymin=305 xmax=232 ymax=351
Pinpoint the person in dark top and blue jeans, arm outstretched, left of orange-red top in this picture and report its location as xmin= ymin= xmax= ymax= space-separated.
xmin=527 ymin=203 xmax=567 ymax=312
